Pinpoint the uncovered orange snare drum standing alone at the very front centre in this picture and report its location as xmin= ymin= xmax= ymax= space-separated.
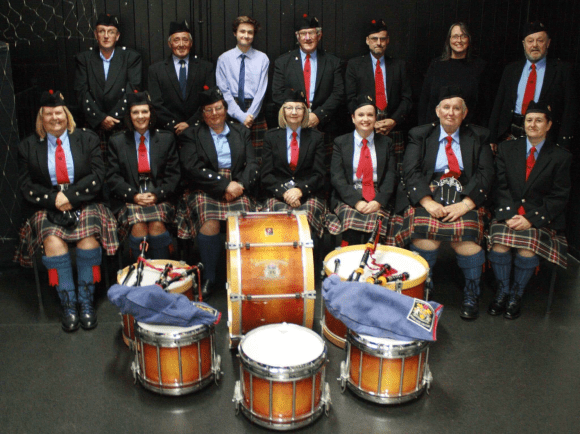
xmin=234 ymin=323 xmax=330 ymax=430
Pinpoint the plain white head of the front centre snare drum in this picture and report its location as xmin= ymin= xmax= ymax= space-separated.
xmin=240 ymin=323 xmax=324 ymax=367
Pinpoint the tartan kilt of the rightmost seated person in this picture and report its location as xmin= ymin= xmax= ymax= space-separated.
xmin=487 ymin=220 xmax=568 ymax=268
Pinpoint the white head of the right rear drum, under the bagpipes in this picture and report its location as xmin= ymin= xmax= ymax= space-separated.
xmin=324 ymin=246 xmax=427 ymax=282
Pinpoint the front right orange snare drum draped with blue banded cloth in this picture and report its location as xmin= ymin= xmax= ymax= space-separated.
xmin=339 ymin=330 xmax=432 ymax=404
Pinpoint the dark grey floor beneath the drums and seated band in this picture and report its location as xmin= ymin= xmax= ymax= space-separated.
xmin=0 ymin=244 xmax=580 ymax=434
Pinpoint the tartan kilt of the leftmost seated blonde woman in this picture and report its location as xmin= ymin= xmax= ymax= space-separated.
xmin=13 ymin=203 xmax=119 ymax=267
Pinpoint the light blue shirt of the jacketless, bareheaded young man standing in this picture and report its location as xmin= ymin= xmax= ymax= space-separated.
xmin=215 ymin=47 xmax=270 ymax=123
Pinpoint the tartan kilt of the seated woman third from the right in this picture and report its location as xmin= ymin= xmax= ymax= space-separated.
xmin=326 ymin=202 xmax=391 ymax=244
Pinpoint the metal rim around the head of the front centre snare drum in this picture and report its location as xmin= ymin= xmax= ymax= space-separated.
xmin=238 ymin=323 xmax=328 ymax=381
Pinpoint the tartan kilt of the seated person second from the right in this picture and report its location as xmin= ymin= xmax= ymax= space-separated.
xmin=389 ymin=206 xmax=490 ymax=247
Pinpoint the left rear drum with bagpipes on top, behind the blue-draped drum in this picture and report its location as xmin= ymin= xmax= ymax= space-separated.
xmin=117 ymin=259 xmax=193 ymax=348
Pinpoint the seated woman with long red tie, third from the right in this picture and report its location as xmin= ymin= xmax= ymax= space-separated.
xmin=327 ymin=95 xmax=396 ymax=246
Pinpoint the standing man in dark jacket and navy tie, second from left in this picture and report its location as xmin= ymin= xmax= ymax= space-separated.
xmin=148 ymin=21 xmax=215 ymax=135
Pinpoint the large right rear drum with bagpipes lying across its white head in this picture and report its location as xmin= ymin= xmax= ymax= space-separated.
xmin=322 ymin=245 xmax=429 ymax=348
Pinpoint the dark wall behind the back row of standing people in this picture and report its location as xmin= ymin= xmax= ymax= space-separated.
xmin=0 ymin=0 xmax=580 ymax=258
